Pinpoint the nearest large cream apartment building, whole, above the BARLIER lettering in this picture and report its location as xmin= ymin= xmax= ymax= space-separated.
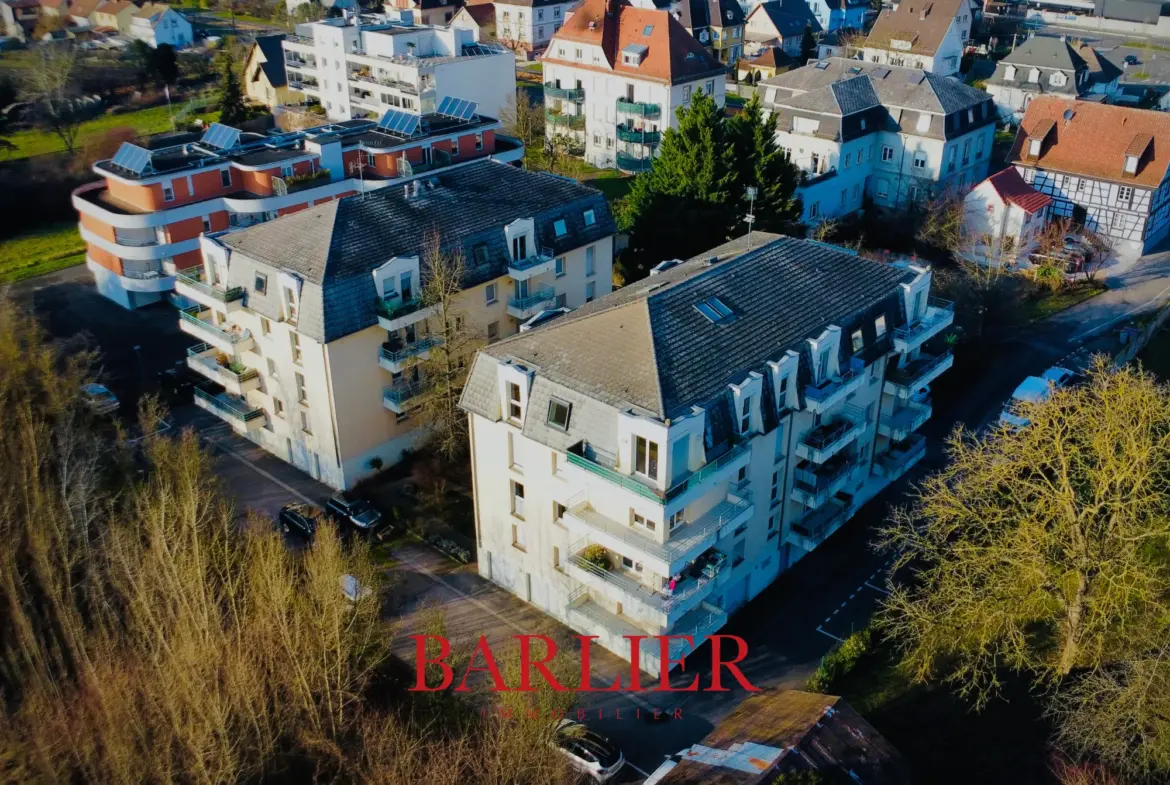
xmin=462 ymin=234 xmax=952 ymax=674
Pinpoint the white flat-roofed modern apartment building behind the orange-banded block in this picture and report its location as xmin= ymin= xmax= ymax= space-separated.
xmin=282 ymin=14 xmax=516 ymax=120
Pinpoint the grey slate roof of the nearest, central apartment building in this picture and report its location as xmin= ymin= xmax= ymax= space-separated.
xmin=463 ymin=237 xmax=914 ymax=423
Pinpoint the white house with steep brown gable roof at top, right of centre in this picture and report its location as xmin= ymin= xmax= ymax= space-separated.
xmin=862 ymin=0 xmax=973 ymax=76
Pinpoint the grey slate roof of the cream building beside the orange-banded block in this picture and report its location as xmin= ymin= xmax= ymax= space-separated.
xmin=220 ymin=160 xmax=617 ymax=343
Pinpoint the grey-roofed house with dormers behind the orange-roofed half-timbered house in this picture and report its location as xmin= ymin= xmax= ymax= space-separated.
xmin=985 ymin=36 xmax=1121 ymax=123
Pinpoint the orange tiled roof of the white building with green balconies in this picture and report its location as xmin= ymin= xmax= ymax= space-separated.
xmin=542 ymin=0 xmax=725 ymax=84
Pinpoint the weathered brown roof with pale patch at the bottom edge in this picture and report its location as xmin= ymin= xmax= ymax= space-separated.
xmin=645 ymin=690 xmax=910 ymax=785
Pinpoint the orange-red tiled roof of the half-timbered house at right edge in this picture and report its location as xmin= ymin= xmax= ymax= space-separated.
xmin=1007 ymin=96 xmax=1170 ymax=187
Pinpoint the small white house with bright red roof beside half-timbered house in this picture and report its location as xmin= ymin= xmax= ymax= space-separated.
xmin=963 ymin=166 xmax=1052 ymax=263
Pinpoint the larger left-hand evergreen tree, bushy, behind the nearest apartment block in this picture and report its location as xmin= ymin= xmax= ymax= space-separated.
xmin=618 ymin=91 xmax=738 ymax=281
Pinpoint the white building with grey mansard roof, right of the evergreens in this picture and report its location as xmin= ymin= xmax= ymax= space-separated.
xmin=761 ymin=57 xmax=997 ymax=223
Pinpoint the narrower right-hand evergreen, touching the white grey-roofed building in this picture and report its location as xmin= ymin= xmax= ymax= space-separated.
xmin=728 ymin=95 xmax=803 ymax=234
